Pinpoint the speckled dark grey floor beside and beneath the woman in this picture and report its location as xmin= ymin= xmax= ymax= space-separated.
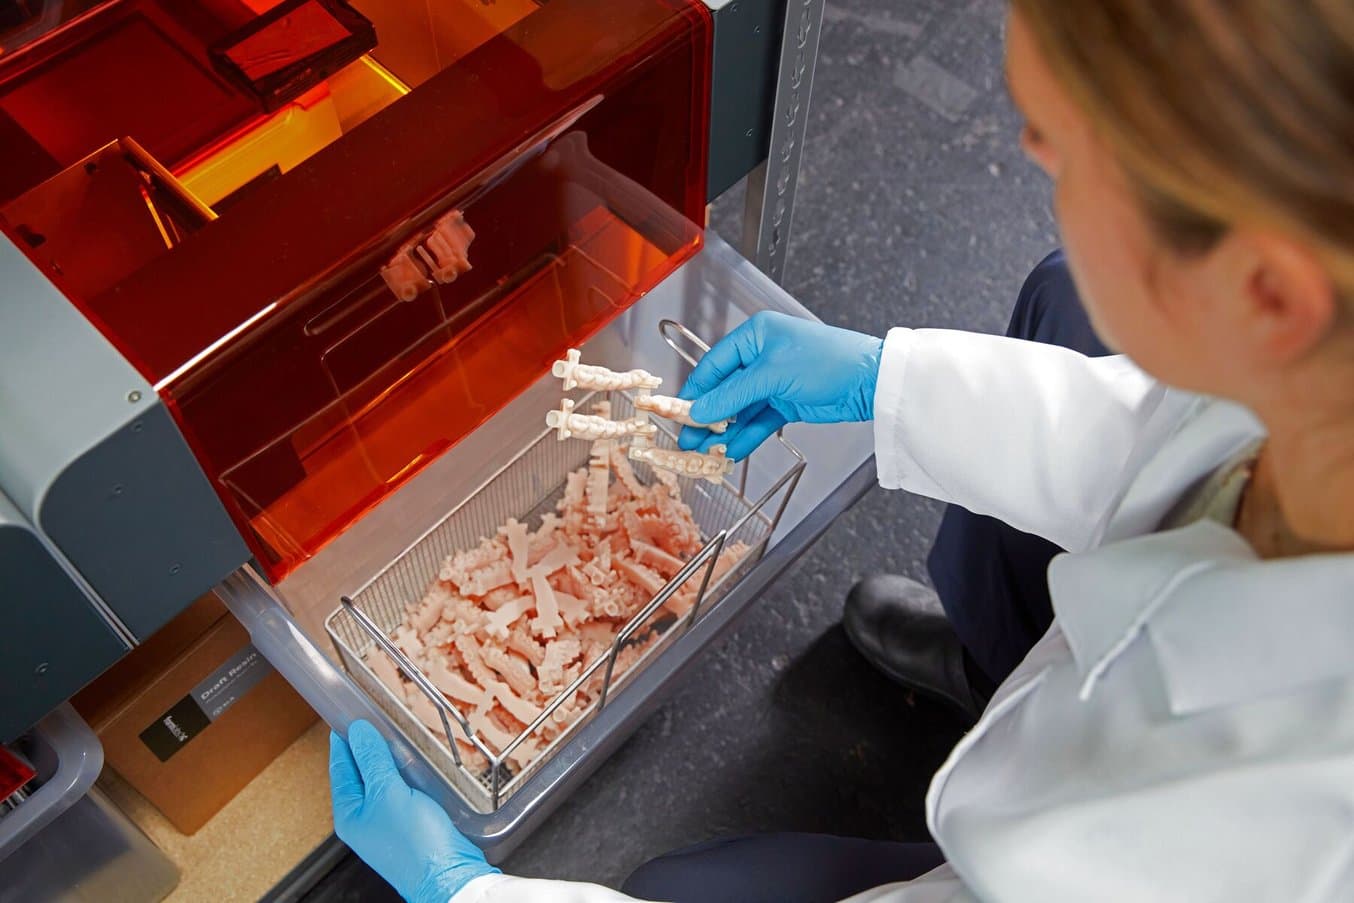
xmin=307 ymin=0 xmax=1056 ymax=900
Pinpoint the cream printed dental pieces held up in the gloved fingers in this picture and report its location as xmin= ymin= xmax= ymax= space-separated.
xmin=546 ymin=348 xmax=734 ymax=484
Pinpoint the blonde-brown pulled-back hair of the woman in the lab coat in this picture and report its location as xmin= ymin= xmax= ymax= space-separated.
xmin=1011 ymin=0 xmax=1354 ymax=299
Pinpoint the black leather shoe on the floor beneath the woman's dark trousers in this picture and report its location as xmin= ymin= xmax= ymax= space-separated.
xmin=842 ymin=574 xmax=988 ymax=722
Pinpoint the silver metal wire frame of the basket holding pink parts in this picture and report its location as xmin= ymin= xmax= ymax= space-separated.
xmin=325 ymin=320 xmax=807 ymax=811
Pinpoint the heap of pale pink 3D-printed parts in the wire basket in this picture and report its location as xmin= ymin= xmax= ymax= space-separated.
xmin=366 ymin=352 xmax=749 ymax=773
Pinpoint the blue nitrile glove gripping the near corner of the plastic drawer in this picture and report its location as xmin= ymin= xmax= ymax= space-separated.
xmin=329 ymin=722 xmax=498 ymax=903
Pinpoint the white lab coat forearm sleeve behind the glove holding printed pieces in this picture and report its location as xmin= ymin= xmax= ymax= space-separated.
xmin=875 ymin=329 xmax=1186 ymax=551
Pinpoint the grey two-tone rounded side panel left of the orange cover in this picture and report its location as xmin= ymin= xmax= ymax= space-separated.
xmin=0 ymin=238 xmax=249 ymax=642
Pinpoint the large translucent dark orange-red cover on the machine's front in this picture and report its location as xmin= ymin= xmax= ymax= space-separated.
xmin=0 ymin=0 xmax=711 ymax=579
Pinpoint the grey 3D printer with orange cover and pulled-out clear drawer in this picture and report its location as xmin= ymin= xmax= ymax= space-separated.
xmin=0 ymin=0 xmax=872 ymax=857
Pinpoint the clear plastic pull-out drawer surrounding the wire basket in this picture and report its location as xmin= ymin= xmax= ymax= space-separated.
xmin=217 ymin=234 xmax=876 ymax=862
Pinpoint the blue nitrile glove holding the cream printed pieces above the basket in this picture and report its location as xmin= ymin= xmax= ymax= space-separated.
xmin=678 ymin=310 xmax=884 ymax=460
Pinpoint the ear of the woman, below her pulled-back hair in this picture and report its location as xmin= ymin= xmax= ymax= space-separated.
xmin=1223 ymin=230 xmax=1339 ymax=364
